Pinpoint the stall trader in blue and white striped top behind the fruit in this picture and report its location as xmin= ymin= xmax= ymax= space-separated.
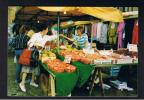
xmin=74 ymin=26 xmax=88 ymax=49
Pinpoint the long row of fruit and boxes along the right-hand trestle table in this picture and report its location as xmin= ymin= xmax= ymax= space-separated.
xmin=60 ymin=49 xmax=137 ymax=64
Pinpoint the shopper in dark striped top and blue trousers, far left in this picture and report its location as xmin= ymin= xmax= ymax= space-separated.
xmin=10 ymin=25 xmax=30 ymax=83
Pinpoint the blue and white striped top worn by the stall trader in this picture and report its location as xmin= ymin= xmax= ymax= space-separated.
xmin=74 ymin=33 xmax=88 ymax=49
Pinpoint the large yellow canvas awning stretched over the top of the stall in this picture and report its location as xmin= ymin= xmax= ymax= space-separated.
xmin=38 ymin=6 xmax=123 ymax=22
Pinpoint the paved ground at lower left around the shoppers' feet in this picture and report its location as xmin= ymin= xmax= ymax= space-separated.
xmin=7 ymin=57 xmax=42 ymax=96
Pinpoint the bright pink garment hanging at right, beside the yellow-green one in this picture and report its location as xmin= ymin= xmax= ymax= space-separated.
xmin=117 ymin=22 xmax=125 ymax=48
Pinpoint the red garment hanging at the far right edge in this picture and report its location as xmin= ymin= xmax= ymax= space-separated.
xmin=132 ymin=20 xmax=138 ymax=44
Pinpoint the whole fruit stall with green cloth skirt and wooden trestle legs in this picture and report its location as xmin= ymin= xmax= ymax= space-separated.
xmin=38 ymin=45 xmax=138 ymax=96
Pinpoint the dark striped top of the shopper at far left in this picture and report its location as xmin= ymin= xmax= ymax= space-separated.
xmin=10 ymin=34 xmax=30 ymax=49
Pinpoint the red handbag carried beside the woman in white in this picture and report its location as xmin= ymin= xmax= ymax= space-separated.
xmin=18 ymin=49 xmax=32 ymax=65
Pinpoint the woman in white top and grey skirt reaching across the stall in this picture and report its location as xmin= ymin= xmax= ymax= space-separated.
xmin=19 ymin=24 xmax=57 ymax=92
